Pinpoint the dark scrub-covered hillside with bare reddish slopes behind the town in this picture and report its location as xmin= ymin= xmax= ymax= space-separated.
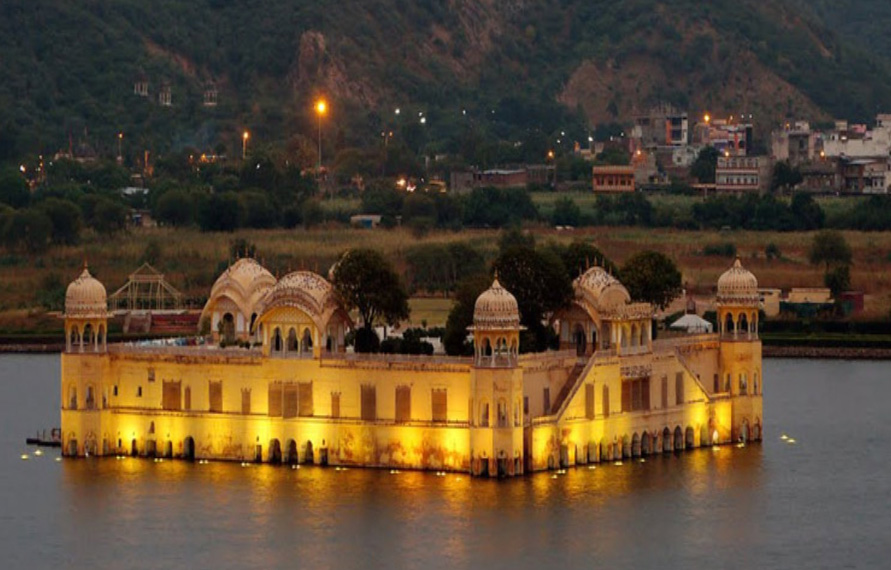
xmin=0 ymin=0 xmax=891 ymax=160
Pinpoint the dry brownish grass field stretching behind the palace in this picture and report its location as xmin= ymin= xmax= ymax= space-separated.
xmin=0 ymin=219 xmax=891 ymax=328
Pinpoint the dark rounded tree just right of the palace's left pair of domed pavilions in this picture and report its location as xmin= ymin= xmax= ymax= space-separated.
xmin=333 ymin=249 xmax=409 ymax=351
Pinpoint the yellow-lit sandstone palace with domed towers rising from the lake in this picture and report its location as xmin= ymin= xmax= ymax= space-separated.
xmin=61 ymin=255 xmax=763 ymax=477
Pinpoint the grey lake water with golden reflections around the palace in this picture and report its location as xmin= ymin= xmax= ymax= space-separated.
xmin=0 ymin=355 xmax=891 ymax=570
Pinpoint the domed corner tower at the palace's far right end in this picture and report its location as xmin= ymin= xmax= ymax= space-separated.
xmin=716 ymin=258 xmax=762 ymax=441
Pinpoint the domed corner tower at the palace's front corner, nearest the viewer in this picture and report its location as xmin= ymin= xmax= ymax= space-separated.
xmin=470 ymin=276 xmax=523 ymax=477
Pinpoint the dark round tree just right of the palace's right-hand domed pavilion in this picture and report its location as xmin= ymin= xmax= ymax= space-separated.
xmin=620 ymin=251 xmax=681 ymax=309
